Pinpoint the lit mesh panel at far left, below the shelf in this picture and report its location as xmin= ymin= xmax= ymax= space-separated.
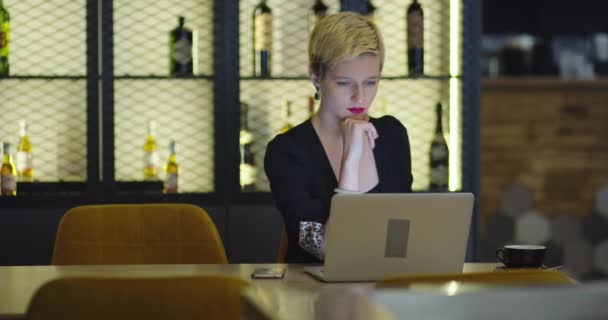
xmin=0 ymin=79 xmax=87 ymax=181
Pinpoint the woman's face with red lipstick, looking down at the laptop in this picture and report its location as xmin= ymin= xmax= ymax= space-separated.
xmin=319 ymin=54 xmax=380 ymax=119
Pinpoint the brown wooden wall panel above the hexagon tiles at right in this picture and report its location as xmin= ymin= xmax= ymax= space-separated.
xmin=481 ymin=79 xmax=608 ymax=224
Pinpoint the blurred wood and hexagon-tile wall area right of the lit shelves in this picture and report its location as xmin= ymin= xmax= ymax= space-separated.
xmin=479 ymin=0 xmax=608 ymax=279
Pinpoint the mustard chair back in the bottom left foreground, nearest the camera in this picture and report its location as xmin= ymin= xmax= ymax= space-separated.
xmin=27 ymin=275 xmax=248 ymax=320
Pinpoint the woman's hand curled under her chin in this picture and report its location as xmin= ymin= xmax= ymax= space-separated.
xmin=342 ymin=117 xmax=378 ymax=165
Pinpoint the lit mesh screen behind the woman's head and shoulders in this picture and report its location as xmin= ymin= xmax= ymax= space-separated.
xmin=239 ymin=0 xmax=462 ymax=191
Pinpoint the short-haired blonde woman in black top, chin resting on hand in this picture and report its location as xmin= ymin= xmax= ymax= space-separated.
xmin=264 ymin=12 xmax=412 ymax=263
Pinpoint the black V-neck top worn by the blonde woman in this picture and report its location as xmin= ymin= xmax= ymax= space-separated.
xmin=264 ymin=116 xmax=413 ymax=263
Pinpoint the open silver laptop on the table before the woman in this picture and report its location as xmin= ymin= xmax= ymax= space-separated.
xmin=305 ymin=193 xmax=474 ymax=282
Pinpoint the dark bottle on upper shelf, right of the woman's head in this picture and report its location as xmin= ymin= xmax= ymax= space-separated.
xmin=407 ymin=0 xmax=424 ymax=76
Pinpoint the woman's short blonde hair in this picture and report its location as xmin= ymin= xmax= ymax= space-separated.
xmin=308 ymin=12 xmax=384 ymax=78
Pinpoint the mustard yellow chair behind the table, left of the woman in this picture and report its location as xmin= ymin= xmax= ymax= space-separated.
xmin=52 ymin=204 xmax=228 ymax=265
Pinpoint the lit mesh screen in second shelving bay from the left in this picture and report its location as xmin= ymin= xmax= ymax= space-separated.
xmin=113 ymin=0 xmax=214 ymax=192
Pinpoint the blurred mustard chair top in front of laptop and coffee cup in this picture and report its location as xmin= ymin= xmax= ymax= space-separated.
xmin=376 ymin=269 xmax=576 ymax=288
